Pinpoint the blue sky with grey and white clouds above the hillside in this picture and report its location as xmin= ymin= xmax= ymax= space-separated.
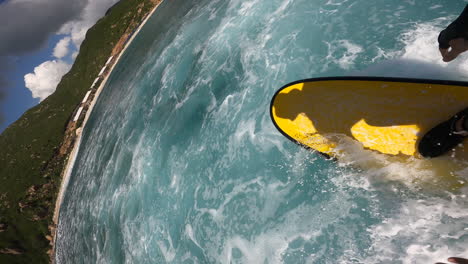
xmin=0 ymin=0 xmax=117 ymax=133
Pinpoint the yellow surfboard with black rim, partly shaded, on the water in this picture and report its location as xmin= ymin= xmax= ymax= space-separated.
xmin=270 ymin=77 xmax=468 ymax=185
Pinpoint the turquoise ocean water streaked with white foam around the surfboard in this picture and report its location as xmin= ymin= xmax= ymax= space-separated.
xmin=56 ymin=0 xmax=468 ymax=264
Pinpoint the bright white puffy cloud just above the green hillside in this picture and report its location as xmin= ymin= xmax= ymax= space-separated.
xmin=24 ymin=60 xmax=71 ymax=101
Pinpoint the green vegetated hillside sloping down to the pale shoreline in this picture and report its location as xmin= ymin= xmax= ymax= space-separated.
xmin=0 ymin=0 xmax=156 ymax=263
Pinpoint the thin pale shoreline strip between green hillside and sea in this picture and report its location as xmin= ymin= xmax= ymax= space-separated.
xmin=51 ymin=0 xmax=163 ymax=263
